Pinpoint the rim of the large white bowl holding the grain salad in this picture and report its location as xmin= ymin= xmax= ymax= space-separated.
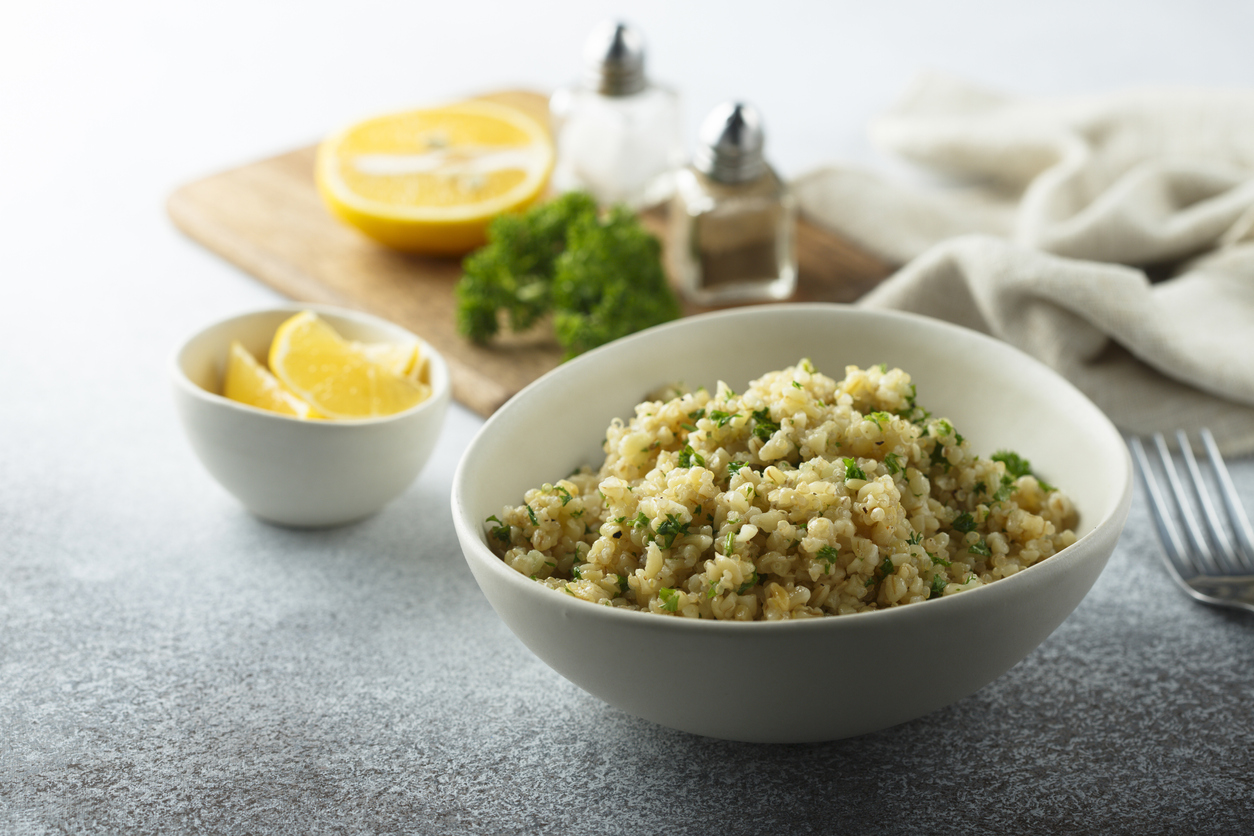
xmin=450 ymin=302 xmax=1132 ymax=632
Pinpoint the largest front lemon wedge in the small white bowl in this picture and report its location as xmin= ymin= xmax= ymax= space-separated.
xmin=270 ymin=311 xmax=431 ymax=419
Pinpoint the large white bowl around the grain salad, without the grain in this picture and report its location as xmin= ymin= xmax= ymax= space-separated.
xmin=453 ymin=305 xmax=1132 ymax=742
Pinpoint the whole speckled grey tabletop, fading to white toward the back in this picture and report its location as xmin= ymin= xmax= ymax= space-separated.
xmin=7 ymin=0 xmax=1254 ymax=836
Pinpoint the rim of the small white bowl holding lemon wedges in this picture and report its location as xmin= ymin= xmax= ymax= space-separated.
xmin=167 ymin=302 xmax=451 ymax=432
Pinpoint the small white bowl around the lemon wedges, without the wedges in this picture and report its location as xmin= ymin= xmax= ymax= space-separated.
xmin=171 ymin=305 xmax=449 ymax=528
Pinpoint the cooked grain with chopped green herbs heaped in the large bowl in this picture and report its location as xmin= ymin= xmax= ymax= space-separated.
xmin=488 ymin=360 xmax=1077 ymax=620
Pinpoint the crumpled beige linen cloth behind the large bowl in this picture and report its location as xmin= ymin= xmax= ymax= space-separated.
xmin=795 ymin=76 xmax=1254 ymax=454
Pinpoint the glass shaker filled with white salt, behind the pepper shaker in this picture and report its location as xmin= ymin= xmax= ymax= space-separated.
xmin=549 ymin=21 xmax=685 ymax=209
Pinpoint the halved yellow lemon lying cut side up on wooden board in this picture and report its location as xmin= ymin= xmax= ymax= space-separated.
xmin=315 ymin=102 xmax=553 ymax=256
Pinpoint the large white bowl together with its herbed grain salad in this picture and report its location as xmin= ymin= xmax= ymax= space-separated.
xmin=453 ymin=305 xmax=1131 ymax=742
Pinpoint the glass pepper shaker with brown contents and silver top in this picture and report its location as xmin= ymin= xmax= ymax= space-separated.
xmin=670 ymin=102 xmax=796 ymax=305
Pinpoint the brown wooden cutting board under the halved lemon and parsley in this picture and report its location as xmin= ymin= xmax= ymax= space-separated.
xmin=167 ymin=91 xmax=890 ymax=416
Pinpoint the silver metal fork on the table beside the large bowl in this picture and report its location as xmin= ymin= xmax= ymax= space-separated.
xmin=1129 ymin=429 xmax=1254 ymax=612
